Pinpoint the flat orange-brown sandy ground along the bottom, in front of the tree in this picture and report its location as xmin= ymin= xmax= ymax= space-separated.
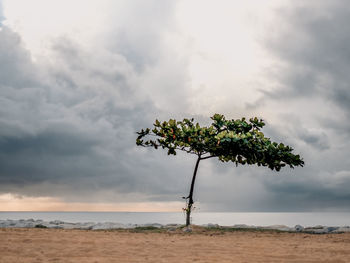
xmin=0 ymin=228 xmax=350 ymax=263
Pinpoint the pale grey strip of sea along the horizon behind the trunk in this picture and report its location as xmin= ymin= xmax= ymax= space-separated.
xmin=0 ymin=212 xmax=350 ymax=227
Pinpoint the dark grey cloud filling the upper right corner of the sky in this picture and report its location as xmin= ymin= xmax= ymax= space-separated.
xmin=267 ymin=0 xmax=350 ymax=113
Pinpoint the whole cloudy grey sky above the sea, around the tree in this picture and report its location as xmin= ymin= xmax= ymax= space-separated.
xmin=0 ymin=0 xmax=350 ymax=212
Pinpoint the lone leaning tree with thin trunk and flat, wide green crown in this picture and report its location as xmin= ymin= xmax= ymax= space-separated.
xmin=136 ymin=114 xmax=304 ymax=226
